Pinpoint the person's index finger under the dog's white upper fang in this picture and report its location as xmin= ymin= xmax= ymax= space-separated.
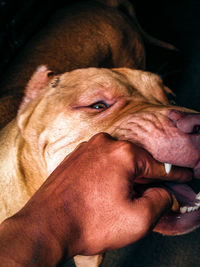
xmin=85 ymin=136 xmax=193 ymax=183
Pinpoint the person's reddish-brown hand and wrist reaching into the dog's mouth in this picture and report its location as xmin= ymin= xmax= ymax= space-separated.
xmin=0 ymin=133 xmax=189 ymax=266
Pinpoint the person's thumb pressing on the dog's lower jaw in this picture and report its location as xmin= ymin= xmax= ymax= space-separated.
xmin=106 ymin=187 xmax=173 ymax=249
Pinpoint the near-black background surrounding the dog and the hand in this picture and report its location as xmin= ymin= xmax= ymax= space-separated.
xmin=0 ymin=0 xmax=200 ymax=267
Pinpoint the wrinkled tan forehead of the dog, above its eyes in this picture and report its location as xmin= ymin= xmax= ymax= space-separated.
xmin=57 ymin=68 xmax=171 ymax=104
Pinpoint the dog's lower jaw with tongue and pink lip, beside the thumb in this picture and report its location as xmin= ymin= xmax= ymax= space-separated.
xmin=154 ymin=182 xmax=200 ymax=235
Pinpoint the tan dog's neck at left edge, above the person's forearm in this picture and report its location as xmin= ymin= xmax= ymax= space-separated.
xmin=0 ymin=120 xmax=46 ymax=221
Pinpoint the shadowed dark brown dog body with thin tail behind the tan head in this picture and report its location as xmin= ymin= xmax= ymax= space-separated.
xmin=0 ymin=0 xmax=174 ymax=128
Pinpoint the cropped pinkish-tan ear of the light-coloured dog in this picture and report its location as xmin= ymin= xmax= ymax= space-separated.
xmin=18 ymin=65 xmax=53 ymax=112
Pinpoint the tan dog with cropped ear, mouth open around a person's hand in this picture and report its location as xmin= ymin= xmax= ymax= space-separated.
xmin=0 ymin=66 xmax=200 ymax=266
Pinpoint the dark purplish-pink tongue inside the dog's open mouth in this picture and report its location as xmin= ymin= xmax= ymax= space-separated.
xmin=165 ymin=182 xmax=197 ymax=206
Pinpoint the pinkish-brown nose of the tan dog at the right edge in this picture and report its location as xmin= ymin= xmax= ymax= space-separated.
xmin=168 ymin=110 xmax=200 ymax=135
